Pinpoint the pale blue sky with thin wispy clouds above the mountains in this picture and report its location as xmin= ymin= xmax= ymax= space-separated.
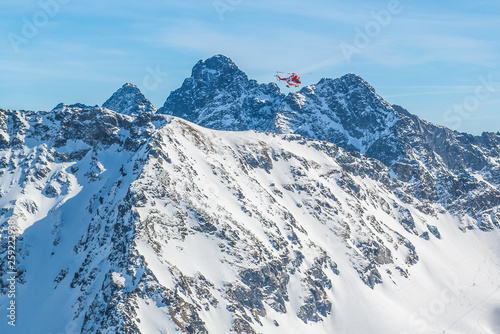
xmin=0 ymin=0 xmax=500 ymax=134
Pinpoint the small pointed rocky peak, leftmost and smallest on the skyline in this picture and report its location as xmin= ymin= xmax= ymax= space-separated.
xmin=102 ymin=83 xmax=156 ymax=115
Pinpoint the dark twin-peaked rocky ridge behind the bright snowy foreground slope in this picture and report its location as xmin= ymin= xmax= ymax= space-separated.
xmin=158 ymin=55 xmax=500 ymax=229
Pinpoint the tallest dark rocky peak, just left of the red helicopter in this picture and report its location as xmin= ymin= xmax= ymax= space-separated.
xmin=158 ymin=55 xmax=284 ymax=131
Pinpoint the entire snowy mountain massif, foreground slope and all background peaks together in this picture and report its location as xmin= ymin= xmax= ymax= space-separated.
xmin=0 ymin=55 xmax=500 ymax=334
